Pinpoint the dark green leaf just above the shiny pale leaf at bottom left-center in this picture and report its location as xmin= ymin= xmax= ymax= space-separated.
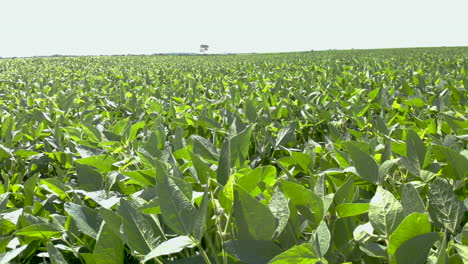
xmin=117 ymin=198 xmax=161 ymax=254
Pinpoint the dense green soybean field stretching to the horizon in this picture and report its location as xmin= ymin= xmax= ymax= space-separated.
xmin=0 ymin=47 xmax=468 ymax=264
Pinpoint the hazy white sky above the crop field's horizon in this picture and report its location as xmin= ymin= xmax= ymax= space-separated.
xmin=0 ymin=0 xmax=468 ymax=57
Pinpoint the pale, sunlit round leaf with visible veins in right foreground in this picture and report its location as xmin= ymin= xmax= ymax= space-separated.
xmin=369 ymin=186 xmax=404 ymax=237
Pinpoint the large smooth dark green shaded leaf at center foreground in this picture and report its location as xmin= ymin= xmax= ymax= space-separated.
xmin=233 ymin=185 xmax=277 ymax=240
